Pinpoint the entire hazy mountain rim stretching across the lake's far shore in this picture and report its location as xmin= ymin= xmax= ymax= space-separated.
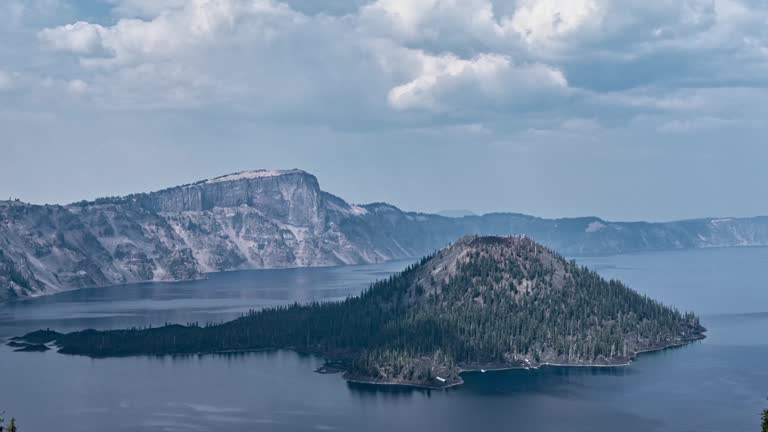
xmin=0 ymin=170 xmax=768 ymax=301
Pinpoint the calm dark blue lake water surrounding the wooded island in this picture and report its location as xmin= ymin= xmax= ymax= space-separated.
xmin=0 ymin=248 xmax=768 ymax=432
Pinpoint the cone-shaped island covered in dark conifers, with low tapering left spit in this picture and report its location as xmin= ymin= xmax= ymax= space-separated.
xmin=13 ymin=237 xmax=705 ymax=388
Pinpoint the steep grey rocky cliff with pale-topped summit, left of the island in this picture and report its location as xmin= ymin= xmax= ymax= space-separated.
xmin=0 ymin=170 xmax=402 ymax=301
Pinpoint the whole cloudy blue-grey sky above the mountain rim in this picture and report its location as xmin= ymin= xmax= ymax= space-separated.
xmin=0 ymin=0 xmax=768 ymax=221
